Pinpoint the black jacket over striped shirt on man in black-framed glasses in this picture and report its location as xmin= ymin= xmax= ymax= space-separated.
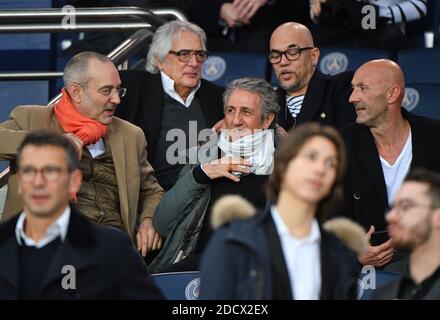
xmin=278 ymin=70 xmax=356 ymax=130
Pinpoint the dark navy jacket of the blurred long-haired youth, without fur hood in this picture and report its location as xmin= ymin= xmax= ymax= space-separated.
xmin=200 ymin=209 xmax=360 ymax=300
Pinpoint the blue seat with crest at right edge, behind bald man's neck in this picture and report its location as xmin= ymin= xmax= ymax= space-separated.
xmin=403 ymin=83 xmax=440 ymax=120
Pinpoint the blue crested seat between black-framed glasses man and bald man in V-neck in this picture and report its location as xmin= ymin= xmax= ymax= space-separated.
xmin=318 ymin=47 xmax=391 ymax=75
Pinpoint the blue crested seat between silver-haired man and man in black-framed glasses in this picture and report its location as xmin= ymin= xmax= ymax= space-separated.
xmin=202 ymin=52 xmax=268 ymax=86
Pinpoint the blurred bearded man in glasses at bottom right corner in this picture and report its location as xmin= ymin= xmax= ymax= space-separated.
xmin=373 ymin=169 xmax=440 ymax=300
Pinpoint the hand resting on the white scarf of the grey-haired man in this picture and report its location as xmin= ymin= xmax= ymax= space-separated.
xmin=203 ymin=157 xmax=252 ymax=182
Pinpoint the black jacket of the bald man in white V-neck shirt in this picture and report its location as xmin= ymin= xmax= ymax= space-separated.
xmin=339 ymin=108 xmax=440 ymax=231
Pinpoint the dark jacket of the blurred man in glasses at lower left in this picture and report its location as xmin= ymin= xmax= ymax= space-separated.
xmin=0 ymin=207 xmax=163 ymax=300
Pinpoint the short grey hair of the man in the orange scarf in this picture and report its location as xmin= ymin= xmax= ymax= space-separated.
xmin=63 ymin=51 xmax=113 ymax=88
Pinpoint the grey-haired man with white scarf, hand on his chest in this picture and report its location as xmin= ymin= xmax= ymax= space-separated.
xmin=149 ymin=78 xmax=279 ymax=272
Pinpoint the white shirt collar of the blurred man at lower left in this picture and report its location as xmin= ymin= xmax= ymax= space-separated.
xmin=15 ymin=206 xmax=70 ymax=249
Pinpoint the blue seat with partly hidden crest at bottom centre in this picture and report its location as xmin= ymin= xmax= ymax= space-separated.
xmin=151 ymin=271 xmax=200 ymax=300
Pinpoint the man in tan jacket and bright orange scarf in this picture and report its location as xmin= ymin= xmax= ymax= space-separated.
xmin=0 ymin=52 xmax=163 ymax=255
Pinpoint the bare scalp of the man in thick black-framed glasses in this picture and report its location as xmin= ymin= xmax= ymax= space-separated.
xmin=270 ymin=22 xmax=315 ymax=48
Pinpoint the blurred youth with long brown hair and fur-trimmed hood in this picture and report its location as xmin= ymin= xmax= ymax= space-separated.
xmin=200 ymin=123 xmax=366 ymax=300
